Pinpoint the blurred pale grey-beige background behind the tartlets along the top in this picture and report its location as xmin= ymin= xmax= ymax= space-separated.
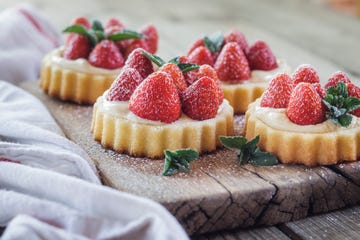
xmin=0 ymin=0 xmax=360 ymax=81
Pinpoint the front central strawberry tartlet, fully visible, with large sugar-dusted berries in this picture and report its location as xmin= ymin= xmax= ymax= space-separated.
xmin=91 ymin=50 xmax=234 ymax=158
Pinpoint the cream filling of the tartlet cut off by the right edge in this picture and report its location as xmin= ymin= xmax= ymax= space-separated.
xmin=250 ymin=99 xmax=360 ymax=133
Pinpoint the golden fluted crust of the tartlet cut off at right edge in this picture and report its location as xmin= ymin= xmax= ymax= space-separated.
xmin=243 ymin=101 xmax=360 ymax=166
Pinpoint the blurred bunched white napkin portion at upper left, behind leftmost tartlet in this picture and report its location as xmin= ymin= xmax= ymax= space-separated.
xmin=0 ymin=4 xmax=61 ymax=84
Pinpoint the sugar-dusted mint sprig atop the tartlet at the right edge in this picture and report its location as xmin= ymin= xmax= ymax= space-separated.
xmin=323 ymin=82 xmax=360 ymax=127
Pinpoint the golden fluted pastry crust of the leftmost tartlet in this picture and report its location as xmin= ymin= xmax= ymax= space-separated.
xmin=40 ymin=48 xmax=120 ymax=104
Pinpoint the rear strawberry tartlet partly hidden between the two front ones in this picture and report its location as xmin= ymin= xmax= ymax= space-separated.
xmin=187 ymin=30 xmax=290 ymax=114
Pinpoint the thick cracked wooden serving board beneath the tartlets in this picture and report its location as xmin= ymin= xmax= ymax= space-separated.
xmin=22 ymin=82 xmax=360 ymax=234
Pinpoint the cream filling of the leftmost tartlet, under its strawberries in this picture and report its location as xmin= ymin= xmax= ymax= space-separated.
xmin=43 ymin=46 xmax=121 ymax=75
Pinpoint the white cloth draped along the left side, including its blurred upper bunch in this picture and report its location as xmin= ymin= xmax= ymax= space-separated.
xmin=0 ymin=6 xmax=188 ymax=240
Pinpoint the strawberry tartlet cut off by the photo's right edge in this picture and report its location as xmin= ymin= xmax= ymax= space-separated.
xmin=243 ymin=66 xmax=360 ymax=166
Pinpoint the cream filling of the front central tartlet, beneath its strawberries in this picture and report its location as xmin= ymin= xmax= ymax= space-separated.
xmin=97 ymin=91 xmax=232 ymax=126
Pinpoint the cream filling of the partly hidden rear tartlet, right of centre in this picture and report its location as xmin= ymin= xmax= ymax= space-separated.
xmin=221 ymin=59 xmax=291 ymax=86
